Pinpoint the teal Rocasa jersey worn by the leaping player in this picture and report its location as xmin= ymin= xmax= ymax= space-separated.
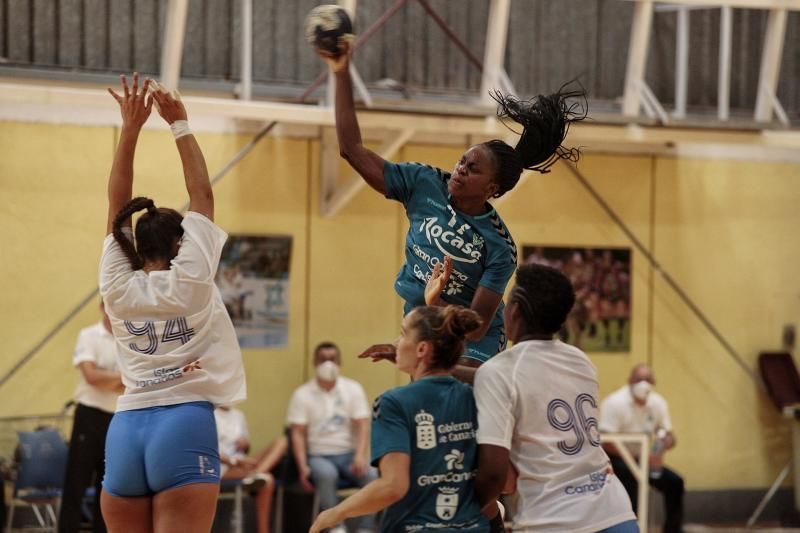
xmin=383 ymin=161 xmax=517 ymax=359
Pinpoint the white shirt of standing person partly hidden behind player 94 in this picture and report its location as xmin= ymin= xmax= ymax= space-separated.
xmin=72 ymin=322 xmax=119 ymax=413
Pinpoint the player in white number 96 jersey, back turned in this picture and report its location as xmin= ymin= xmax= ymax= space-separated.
xmin=475 ymin=264 xmax=639 ymax=533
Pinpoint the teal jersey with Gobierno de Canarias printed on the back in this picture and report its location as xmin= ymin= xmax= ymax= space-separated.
xmin=372 ymin=376 xmax=489 ymax=533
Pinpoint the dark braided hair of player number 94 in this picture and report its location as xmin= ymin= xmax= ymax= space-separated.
xmin=113 ymin=196 xmax=183 ymax=270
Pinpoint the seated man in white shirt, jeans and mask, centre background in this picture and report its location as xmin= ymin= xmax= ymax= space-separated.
xmin=287 ymin=342 xmax=376 ymax=533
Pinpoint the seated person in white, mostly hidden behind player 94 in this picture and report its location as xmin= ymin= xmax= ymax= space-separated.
xmin=214 ymin=406 xmax=289 ymax=533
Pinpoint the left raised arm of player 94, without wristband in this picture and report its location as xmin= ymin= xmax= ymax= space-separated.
xmin=106 ymin=72 xmax=153 ymax=234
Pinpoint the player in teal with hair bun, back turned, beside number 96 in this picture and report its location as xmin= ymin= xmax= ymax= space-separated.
xmin=311 ymin=305 xmax=496 ymax=533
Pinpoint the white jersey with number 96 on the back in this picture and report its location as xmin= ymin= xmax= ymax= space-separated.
xmin=475 ymin=341 xmax=636 ymax=533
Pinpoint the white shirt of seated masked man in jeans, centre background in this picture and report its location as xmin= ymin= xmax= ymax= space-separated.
xmin=287 ymin=376 xmax=370 ymax=455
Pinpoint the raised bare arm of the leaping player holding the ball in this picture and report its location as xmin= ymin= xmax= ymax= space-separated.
xmin=317 ymin=43 xmax=386 ymax=194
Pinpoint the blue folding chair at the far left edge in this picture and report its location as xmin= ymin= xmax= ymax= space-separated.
xmin=6 ymin=428 xmax=67 ymax=533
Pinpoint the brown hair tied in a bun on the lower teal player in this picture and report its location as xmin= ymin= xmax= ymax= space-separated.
xmin=411 ymin=305 xmax=483 ymax=370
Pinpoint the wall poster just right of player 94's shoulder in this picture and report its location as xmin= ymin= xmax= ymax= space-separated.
xmin=216 ymin=235 xmax=292 ymax=348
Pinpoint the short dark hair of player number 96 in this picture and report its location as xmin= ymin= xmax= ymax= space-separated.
xmin=508 ymin=263 xmax=575 ymax=334
